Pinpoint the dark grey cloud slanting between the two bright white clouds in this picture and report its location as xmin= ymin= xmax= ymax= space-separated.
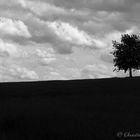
xmin=25 ymin=17 xmax=72 ymax=54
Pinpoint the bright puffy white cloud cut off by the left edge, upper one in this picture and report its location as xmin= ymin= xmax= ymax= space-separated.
xmin=0 ymin=17 xmax=31 ymax=38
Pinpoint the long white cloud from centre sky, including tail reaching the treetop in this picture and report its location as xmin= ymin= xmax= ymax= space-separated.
xmin=47 ymin=21 xmax=117 ymax=49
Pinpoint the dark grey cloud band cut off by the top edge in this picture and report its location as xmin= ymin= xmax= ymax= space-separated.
xmin=43 ymin=0 xmax=128 ymax=11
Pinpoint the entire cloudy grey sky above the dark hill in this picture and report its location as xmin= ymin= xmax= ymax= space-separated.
xmin=0 ymin=0 xmax=140 ymax=82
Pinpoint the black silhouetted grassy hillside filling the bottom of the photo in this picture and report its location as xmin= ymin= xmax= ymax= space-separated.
xmin=0 ymin=78 xmax=140 ymax=140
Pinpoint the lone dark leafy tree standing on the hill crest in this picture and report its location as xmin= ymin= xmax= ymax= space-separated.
xmin=112 ymin=34 xmax=140 ymax=77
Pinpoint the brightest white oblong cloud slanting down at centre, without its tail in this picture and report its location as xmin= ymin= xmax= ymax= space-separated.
xmin=47 ymin=21 xmax=93 ymax=46
